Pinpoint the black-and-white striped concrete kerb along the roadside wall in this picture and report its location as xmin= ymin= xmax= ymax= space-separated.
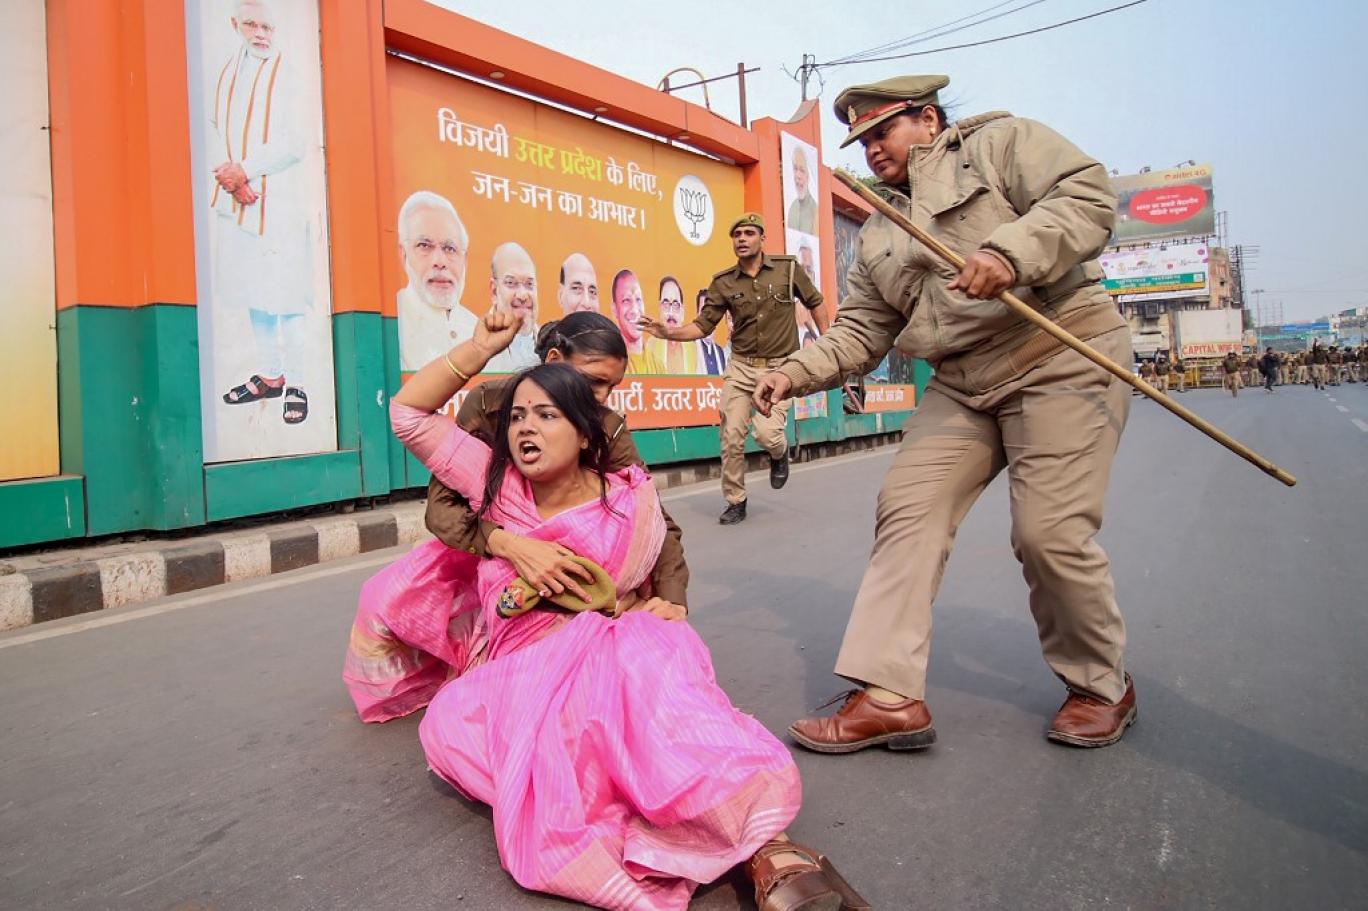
xmin=0 ymin=432 xmax=899 ymax=632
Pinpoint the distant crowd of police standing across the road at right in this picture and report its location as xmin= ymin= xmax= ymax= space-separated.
xmin=1135 ymin=339 xmax=1368 ymax=395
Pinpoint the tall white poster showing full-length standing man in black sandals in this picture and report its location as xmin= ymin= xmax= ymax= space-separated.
xmin=186 ymin=0 xmax=337 ymax=462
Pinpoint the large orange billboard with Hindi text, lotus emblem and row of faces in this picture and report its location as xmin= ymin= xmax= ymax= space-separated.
xmin=386 ymin=57 xmax=744 ymax=428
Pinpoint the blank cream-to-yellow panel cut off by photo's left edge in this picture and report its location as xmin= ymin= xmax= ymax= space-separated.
xmin=0 ymin=3 xmax=60 ymax=481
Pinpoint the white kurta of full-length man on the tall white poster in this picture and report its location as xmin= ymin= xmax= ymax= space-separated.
xmin=208 ymin=47 xmax=313 ymax=316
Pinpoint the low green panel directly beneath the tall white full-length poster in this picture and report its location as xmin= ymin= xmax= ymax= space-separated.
xmin=204 ymin=449 xmax=361 ymax=521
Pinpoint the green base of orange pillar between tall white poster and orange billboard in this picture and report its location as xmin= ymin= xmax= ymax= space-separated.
xmin=332 ymin=313 xmax=393 ymax=495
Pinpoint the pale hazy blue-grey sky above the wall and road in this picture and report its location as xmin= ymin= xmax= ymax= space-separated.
xmin=439 ymin=0 xmax=1368 ymax=321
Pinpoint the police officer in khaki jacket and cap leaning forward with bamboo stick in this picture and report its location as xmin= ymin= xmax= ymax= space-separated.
xmin=755 ymin=75 xmax=1135 ymax=752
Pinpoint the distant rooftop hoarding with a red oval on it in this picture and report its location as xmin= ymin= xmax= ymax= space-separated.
xmin=1112 ymin=164 xmax=1216 ymax=243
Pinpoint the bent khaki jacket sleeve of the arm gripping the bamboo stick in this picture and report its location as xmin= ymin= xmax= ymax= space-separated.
xmin=984 ymin=118 xmax=1116 ymax=286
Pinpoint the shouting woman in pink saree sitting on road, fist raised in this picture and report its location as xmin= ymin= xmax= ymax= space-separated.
xmin=369 ymin=312 xmax=867 ymax=911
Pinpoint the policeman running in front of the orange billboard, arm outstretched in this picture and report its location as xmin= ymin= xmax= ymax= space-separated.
xmin=640 ymin=212 xmax=828 ymax=525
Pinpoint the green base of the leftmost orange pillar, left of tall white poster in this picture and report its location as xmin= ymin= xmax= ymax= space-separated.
xmin=57 ymin=304 xmax=204 ymax=535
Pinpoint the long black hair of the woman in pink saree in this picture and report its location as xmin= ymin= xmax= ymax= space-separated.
xmin=479 ymin=361 xmax=620 ymax=517
